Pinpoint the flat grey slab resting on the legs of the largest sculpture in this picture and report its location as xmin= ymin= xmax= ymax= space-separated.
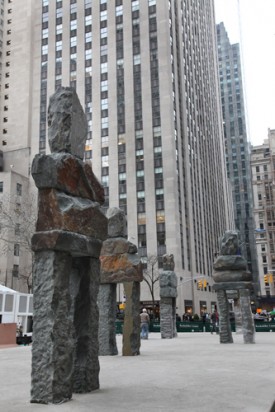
xmin=32 ymin=232 xmax=104 ymax=257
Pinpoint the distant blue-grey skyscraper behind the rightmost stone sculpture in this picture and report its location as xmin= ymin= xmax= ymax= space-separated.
xmin=217 ymin=23 xmax=258 ymax=294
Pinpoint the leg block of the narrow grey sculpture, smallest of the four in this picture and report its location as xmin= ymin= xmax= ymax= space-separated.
xmin=160 ymin=297 xmax=177 ymax=339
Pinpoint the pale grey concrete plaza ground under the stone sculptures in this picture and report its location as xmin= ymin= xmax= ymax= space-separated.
xmin=0 ymin=332 xmax=275 ymax=412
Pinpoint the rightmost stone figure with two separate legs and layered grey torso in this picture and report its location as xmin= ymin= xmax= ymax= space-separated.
xmin=213 ymin=231 xmax=255 ymax=343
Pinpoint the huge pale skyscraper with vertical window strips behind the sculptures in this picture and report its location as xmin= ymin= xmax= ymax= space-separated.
xmin=2 ymin=0 xmax=233 ymax=313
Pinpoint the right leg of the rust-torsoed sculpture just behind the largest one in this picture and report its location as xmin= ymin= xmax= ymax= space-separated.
xmin=122 ymin=282 xmax=140 ymax=356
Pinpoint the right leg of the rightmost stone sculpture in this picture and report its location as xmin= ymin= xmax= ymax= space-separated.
xmin=240 ymin=289 xmax=255 ymax=343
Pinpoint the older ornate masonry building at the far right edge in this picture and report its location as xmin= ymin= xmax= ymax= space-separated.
xmin=251 ymin=129 xmax=275 ymax=298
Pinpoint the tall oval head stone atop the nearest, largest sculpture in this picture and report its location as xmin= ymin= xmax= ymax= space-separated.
xmin=48 ymin=87 xmax=88 ymax=159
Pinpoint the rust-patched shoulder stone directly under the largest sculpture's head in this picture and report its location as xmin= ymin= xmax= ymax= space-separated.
xmin=32 ymin=153 xmax=104 ymax=204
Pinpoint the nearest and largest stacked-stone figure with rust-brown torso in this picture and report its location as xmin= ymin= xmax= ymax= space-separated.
xmin=31 ymin=88 xmax=107 ymax=403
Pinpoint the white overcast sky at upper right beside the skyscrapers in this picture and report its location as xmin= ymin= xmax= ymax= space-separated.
xmin=215 ymin=0 xmax=275 ymax=145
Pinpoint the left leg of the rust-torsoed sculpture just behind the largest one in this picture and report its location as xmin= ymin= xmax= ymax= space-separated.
xmin=98 ymin=283 xmax=118 ymax=356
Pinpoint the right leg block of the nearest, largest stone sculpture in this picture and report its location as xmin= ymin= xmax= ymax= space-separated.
xmin=73 ymin=257 xmax=100 ymax=393
